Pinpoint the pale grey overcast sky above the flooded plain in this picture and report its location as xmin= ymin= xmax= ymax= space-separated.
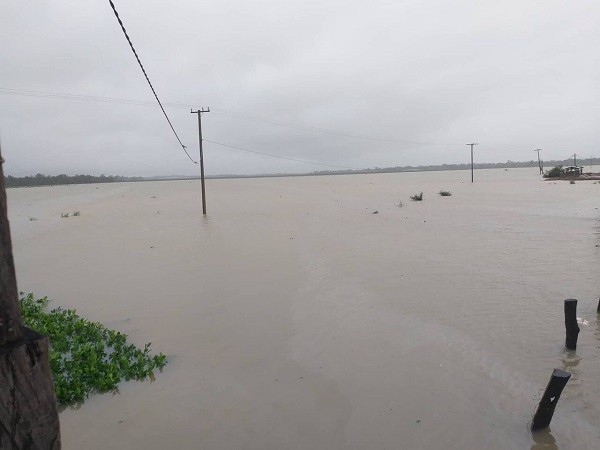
xmin=0 ymin=0 xmax=600 ymax=176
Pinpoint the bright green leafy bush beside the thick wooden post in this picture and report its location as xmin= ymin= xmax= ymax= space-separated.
xmin=20 ymin=293 xmax=167 ymax=405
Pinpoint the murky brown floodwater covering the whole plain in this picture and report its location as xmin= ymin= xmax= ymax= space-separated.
xmin=9 ymin=168 xmax=600 ymax=450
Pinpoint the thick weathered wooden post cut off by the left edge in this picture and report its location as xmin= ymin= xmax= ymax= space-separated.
xmin=0 ymin=147 xmax=60 ymax=450
